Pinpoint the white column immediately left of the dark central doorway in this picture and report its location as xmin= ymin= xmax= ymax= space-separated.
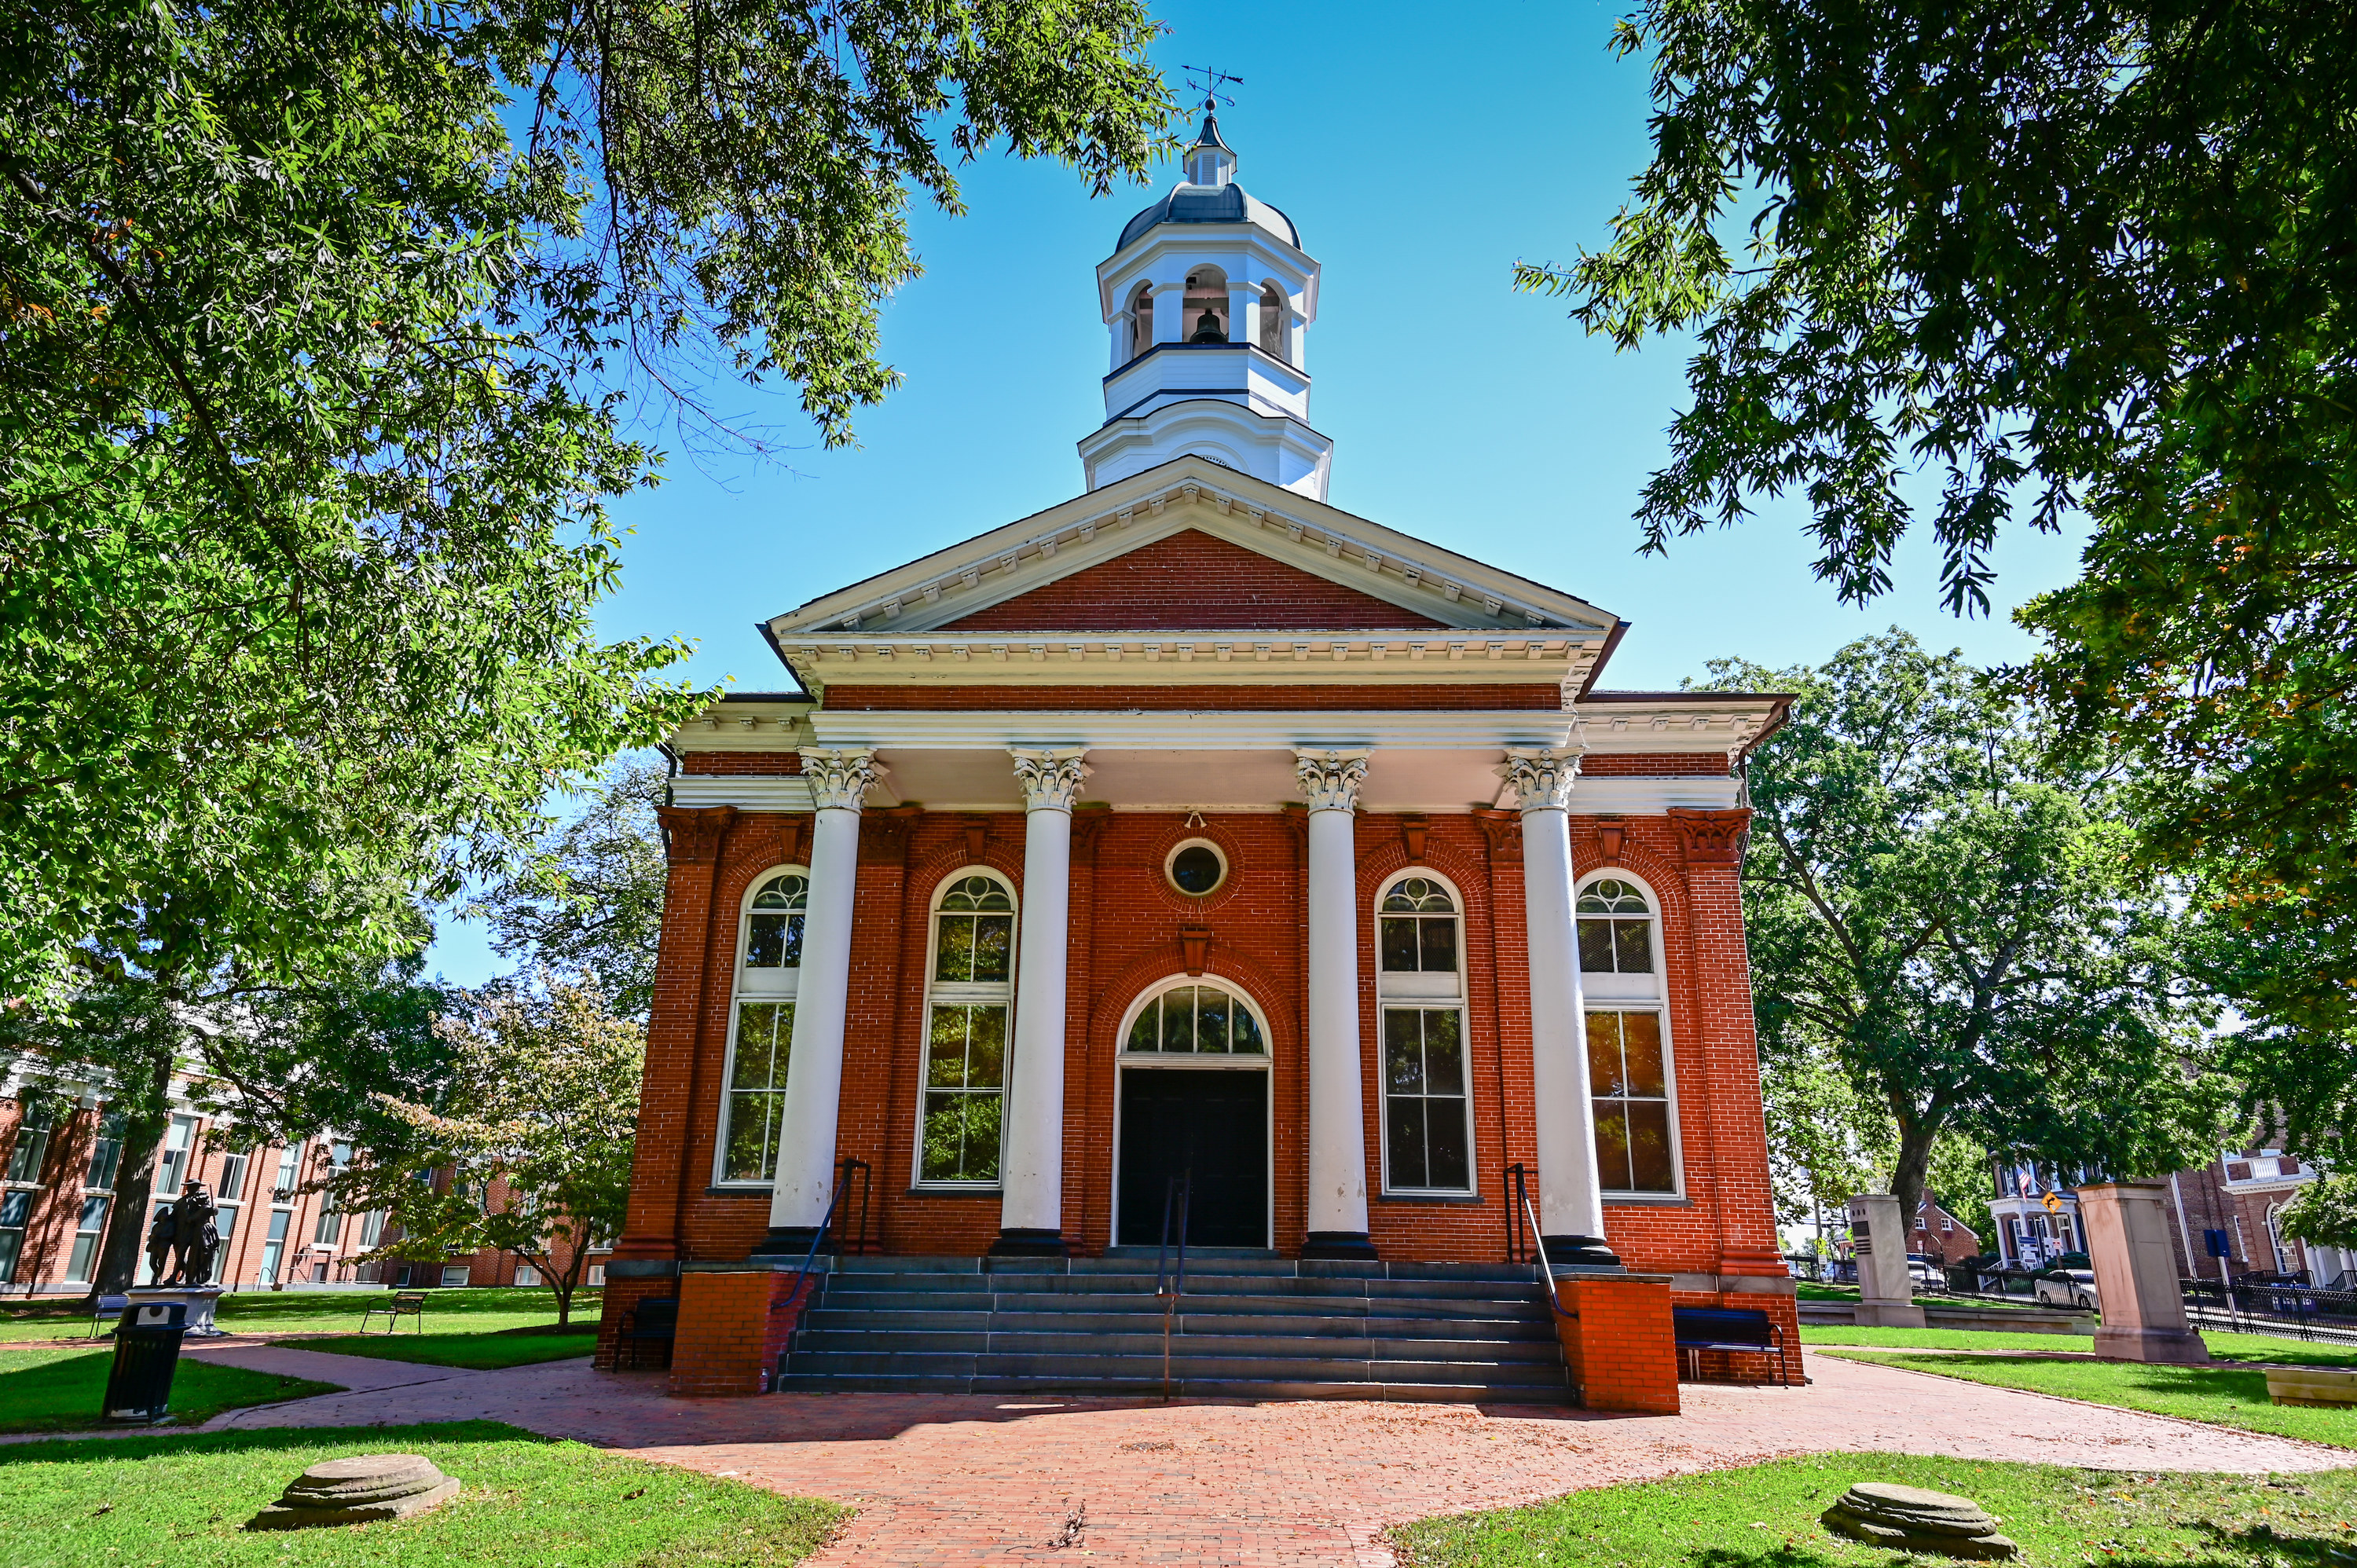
xmin=990 ymin=745 xmax=1089 ymax=1257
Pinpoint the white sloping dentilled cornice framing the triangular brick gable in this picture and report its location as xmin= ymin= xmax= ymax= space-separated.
xmin=768 ymin=457 xmax=1615 ymax=641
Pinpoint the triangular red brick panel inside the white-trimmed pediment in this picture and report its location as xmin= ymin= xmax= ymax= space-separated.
xmin=943 ymin=528 xmax=1447 ymax=632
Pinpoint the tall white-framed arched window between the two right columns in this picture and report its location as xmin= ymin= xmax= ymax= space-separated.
xmin=1374 ymin=875 xmax=1473 ymax=1193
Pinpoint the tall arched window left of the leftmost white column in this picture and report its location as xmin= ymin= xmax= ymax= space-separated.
xmin=714 ymin=870 xmax=811 ymax=1184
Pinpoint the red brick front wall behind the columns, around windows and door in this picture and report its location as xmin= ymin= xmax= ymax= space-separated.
xmin=608 ymin=811 xmax=1796 ymax=1282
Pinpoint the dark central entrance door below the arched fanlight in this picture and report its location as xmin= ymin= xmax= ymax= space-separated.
xmin=1120 ymin=1068 xmax=1268 ymax=1247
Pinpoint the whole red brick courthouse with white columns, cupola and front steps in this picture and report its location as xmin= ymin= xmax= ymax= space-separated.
xmin=601 ymin=123 xmax=1798 ymax=1408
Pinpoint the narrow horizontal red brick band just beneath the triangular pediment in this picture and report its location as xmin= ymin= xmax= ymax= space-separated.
xmin=830 ymin=681 xmax=1565 ymax=712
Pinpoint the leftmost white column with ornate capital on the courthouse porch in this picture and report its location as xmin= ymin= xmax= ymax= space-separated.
xmin=754 ymin=747 xmax=882 ymax=1257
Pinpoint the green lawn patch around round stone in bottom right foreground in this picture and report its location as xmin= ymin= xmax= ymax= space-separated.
xmin=1391 ymin=1455 xmax=2357 ymax=1568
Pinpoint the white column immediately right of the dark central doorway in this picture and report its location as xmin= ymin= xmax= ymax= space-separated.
xmin=1294 ymin=749 xmax=1374 ymax=1257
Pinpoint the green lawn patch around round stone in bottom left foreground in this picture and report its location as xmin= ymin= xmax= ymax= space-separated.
xmin=0 ymin=1422 xmax=849 ymax=1568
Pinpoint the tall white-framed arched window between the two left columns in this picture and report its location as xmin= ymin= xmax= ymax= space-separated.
xmin=917 ymin=870 xmax=1016 ymax=1186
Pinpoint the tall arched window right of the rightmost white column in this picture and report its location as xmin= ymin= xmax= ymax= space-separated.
xmin=1577 ymin=877 xmax=1678 ymax=1196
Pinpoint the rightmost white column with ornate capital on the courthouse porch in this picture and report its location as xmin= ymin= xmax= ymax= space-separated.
xmin=1504 ymin=749 xmax=1619 ymax=1266
